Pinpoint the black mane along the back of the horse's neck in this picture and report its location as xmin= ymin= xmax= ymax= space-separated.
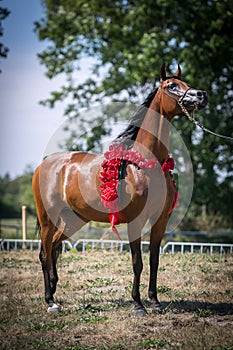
xmin=114 ymin=88 xmax=158 ymax=148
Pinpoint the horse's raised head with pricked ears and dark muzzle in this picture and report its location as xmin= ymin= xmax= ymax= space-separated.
xmin=160 ymin=63 xmax=208 ymax=117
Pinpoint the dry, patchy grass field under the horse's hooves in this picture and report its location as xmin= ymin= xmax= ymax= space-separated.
xmin=0 ymin=251 xmax=233 ymax=350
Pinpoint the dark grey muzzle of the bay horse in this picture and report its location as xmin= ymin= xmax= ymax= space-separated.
xmin=182 ymin=89 xmax=208 ymax=109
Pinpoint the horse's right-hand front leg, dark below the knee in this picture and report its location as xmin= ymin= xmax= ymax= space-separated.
xmin=148 ymin=220 xmax=167 ymax=311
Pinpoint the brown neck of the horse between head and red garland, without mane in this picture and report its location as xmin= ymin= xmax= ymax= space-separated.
xmin=134 ymin=99 xmax=170 ymax=163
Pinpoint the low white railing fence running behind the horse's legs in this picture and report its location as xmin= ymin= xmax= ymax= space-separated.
xmin=0 ymin=239 xmax=233 ymax=255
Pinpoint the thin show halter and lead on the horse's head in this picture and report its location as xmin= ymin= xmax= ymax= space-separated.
xmin=159 ymin=87 xmax=233 ymax=142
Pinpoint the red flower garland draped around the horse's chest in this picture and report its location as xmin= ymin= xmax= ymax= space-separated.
xmin=100 ymin=145 xmax=178 ymax=239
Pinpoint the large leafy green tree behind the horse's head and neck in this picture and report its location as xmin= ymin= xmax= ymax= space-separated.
xmin=35 ymin=0 xmax=233 ymax=228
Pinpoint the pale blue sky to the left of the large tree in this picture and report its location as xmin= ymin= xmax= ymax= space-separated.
xmin=0 ymin=0 xmax=93 ymax=178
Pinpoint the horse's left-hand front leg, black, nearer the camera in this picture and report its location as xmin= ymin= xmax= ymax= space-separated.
xmin=130 ymin=238 xmax=147 ymax=316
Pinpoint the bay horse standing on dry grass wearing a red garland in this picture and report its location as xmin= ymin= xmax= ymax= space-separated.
xmin=32 ymin=64 xmax=207 ymax=316
